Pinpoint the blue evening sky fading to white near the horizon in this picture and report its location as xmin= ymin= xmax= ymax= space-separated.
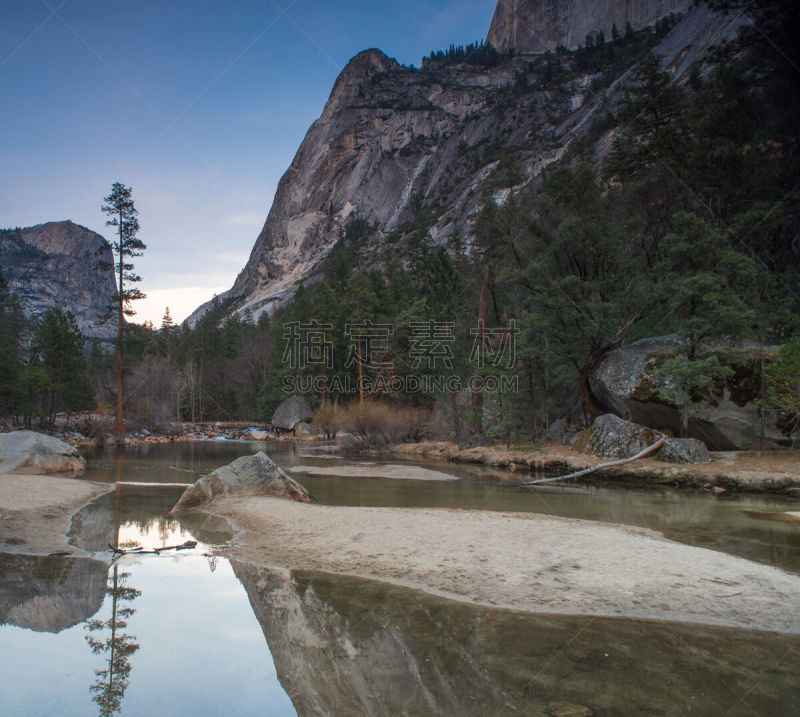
xmin=0 ymin=0 xmax=496 ymax=325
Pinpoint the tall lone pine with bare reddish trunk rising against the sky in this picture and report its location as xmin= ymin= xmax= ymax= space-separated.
xmin=102 ymin=182 xmax=147 ymax=440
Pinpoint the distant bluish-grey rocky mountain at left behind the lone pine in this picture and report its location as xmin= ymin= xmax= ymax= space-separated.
xmin=0 ymin=220 xmax=117 ymax=339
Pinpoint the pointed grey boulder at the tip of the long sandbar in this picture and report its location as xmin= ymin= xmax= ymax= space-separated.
xmin=170 ymin=451 xmax=312 ymax=514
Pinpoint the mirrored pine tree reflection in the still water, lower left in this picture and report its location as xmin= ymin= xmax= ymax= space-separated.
xmin=86 ymin=565 xmax=142 ymax=717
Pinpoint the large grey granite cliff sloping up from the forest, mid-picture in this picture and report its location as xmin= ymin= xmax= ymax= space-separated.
xmin=189 ymin=0 xmax=732 ymax=324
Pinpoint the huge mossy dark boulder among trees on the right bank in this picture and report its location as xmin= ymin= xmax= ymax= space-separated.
xmin=592 ymin=335 xmax=800 ymax=451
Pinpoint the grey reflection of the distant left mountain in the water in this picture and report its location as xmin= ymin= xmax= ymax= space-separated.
xmin=0 ymin=553 xmax=108 ymax=632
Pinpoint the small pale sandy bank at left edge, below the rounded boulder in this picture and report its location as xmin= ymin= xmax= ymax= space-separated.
xmin=0 ymin=475 xmax=114 ymax=555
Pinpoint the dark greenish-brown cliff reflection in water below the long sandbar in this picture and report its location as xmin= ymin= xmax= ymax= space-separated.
xmin=232 ymin=561 xmax=800 ymax=715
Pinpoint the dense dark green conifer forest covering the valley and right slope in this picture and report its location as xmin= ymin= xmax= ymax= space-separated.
xmin=0 ymin=0 xmax=800 ymax=441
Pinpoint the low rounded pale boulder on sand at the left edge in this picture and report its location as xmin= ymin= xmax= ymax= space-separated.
xmin=0 ymin=431 xmax=86 ymax=475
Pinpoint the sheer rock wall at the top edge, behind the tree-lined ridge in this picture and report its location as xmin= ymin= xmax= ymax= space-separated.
xmin=487 ymin=0 xmax=692 ymax=52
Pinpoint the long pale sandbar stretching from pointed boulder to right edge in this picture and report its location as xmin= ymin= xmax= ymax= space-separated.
xmin=211 ymin=497 xmax=800 ymax=632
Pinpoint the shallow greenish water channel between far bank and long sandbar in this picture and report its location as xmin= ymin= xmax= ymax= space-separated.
xmin=85 ymin=441 xmax=800 ymax=572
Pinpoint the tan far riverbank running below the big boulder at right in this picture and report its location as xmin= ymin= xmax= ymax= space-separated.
xmin=383 ymin=442 xmax=800 ymax=494
